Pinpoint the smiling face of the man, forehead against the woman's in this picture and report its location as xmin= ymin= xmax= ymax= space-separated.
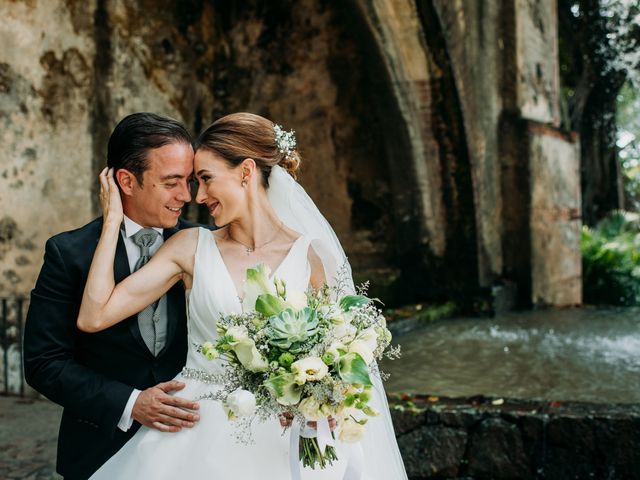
xmin=123 ymin=143 xmax=193 ymax=228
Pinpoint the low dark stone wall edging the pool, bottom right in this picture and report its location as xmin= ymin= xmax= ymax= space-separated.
xmin=391 ymin=396 xmax=640 ymax=480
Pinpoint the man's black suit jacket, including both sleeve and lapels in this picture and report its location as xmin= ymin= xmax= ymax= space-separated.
xmin=24 ymin=218 xmax=193 ymax=479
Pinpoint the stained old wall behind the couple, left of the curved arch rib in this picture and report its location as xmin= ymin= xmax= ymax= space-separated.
xmin=0 ymin=0 xmax=402 ymax=295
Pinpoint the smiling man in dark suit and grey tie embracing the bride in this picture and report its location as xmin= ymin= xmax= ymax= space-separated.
xmin=24 ymin=113 xmax=198 ymax=480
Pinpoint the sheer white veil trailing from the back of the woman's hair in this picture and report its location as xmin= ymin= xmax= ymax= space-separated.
xmin=267 ymin=165 xmax=407 ymax=479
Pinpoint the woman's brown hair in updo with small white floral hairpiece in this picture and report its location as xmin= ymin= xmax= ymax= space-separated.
xmin=194 ymin=112 xmax=300 ymax=187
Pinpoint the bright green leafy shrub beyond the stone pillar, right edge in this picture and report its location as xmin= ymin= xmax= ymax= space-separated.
xmin=580 ymin=211 xmax=640 ymax=305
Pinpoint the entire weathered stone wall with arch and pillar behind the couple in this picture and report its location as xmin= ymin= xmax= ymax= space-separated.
xmin=0 ymin=0 xmax=580 ymax=304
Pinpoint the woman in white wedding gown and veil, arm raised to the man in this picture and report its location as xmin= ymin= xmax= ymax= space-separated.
xmin=78 ymin=113 xmax=407 ymax=480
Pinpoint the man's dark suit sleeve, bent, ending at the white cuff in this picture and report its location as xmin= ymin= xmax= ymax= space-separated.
xmin=24 ymin=238 xmax=133 ymax=435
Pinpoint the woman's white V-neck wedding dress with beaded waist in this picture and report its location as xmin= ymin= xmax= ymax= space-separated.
xmin=91 ymin=228 xmax=407 ymax=480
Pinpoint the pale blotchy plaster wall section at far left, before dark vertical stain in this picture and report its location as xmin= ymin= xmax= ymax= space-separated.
xmin=0 ymin=1 xmax=94 ymax=295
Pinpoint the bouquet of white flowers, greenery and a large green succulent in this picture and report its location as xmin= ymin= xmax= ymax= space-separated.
xmin=198 ymin=265 xmax=399 ymax=468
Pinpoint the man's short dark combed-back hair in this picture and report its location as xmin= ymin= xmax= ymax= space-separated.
xmin=107 ymin=112 xmax=193 ymax=185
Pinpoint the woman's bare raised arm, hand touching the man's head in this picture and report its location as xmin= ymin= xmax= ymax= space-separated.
xmin=77 ymin=171 xmax=197 ymax=332
